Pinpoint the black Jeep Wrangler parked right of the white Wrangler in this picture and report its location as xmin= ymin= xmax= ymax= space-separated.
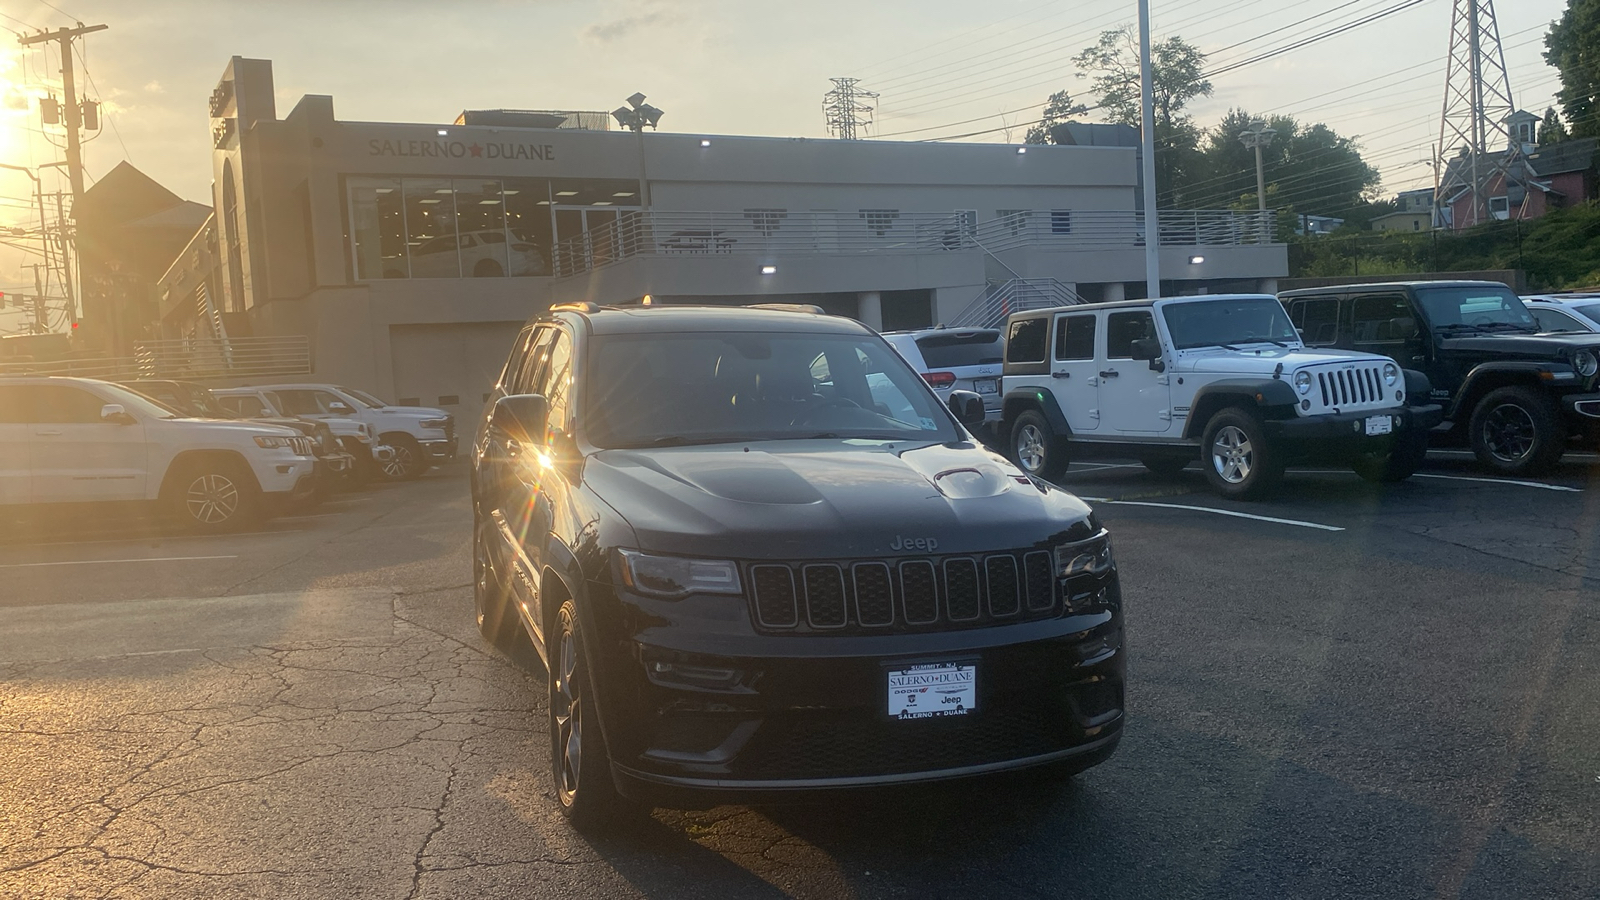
xmin=1278 ymin=282 xmax=1600 ymax=476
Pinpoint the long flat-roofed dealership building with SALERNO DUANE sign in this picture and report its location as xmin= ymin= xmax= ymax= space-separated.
xmin=187 ymin=58 xmax=1288 ymax=413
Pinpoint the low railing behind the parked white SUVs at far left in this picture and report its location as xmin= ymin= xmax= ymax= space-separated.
xmin=0 ymin=335 xmax=312 ymax=381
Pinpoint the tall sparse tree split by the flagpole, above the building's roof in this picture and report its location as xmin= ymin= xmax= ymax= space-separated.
xmin=1072 ymin=26 xmax=1211 ymax=207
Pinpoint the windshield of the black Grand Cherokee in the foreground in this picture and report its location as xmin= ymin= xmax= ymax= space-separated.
xmin=587 ymin=333 xmax=960 ymax=447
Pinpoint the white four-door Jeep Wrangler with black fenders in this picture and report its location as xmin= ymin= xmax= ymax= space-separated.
xmin=1000 ymin=295 xmax=1442 ymax=500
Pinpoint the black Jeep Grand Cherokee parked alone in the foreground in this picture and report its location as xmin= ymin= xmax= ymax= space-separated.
xmin=472 ymin=304 xmax=1123 ymax=828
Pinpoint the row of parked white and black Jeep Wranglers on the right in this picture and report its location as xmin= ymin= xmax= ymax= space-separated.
xmin=998 ymin=282 xmax=1600 ymax=500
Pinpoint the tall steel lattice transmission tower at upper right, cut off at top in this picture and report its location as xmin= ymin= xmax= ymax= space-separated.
xmin=1434 ymin=0 xmax=1522 ymax=226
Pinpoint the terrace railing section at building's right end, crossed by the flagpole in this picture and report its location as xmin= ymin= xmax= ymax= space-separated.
xmin=978 ymin=210 xmax=1274 ymax=253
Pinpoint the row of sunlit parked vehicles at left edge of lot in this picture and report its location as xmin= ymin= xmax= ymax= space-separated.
xmin=0 ymin=376 xmax=454 ymax=532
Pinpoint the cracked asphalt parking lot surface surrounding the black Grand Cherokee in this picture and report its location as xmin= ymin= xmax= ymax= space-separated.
xmin=0 ymin=453 xmax=1600 ymax=898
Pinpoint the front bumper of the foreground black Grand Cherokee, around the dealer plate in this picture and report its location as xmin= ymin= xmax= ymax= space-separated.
xmin=597 ymin=596 xmax=1126 ymax=806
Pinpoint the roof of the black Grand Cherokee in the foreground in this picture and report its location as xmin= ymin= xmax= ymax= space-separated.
xmin=541 ymin=304 xmax=874 ymax=335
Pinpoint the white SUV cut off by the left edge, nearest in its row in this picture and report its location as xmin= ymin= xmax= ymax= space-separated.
xmin=0 ymin=378 xmax=317 ymax=530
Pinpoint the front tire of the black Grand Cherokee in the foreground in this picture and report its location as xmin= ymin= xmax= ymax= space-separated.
xmin=547 ymin=601 xmax=622 ymax=834
